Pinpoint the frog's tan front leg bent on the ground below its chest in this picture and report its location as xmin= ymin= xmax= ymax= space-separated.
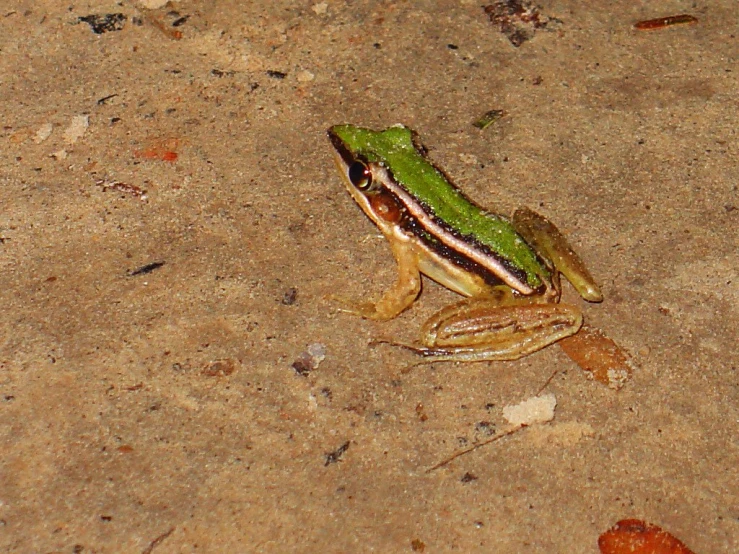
xmin=334 ymin=233 xmax=421 ymax=320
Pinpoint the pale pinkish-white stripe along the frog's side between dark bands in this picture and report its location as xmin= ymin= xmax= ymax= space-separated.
xmin=368 ymin=163 xmax=534 ymax=295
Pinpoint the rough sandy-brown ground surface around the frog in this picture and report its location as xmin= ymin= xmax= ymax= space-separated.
xmin=0 ymin=0 xmax=739 ymax=554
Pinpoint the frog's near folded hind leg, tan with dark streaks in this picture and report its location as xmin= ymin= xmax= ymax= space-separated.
xmin=410 ymin=287 xmax=582 ymax=361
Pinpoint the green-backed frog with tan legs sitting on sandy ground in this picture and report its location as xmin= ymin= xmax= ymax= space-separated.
xmin=327 ymin=124 xmax=603 ymax=362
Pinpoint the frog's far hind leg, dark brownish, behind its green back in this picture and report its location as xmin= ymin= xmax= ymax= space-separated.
xmin=512 ymin=207 xmax=603 ymax=302
